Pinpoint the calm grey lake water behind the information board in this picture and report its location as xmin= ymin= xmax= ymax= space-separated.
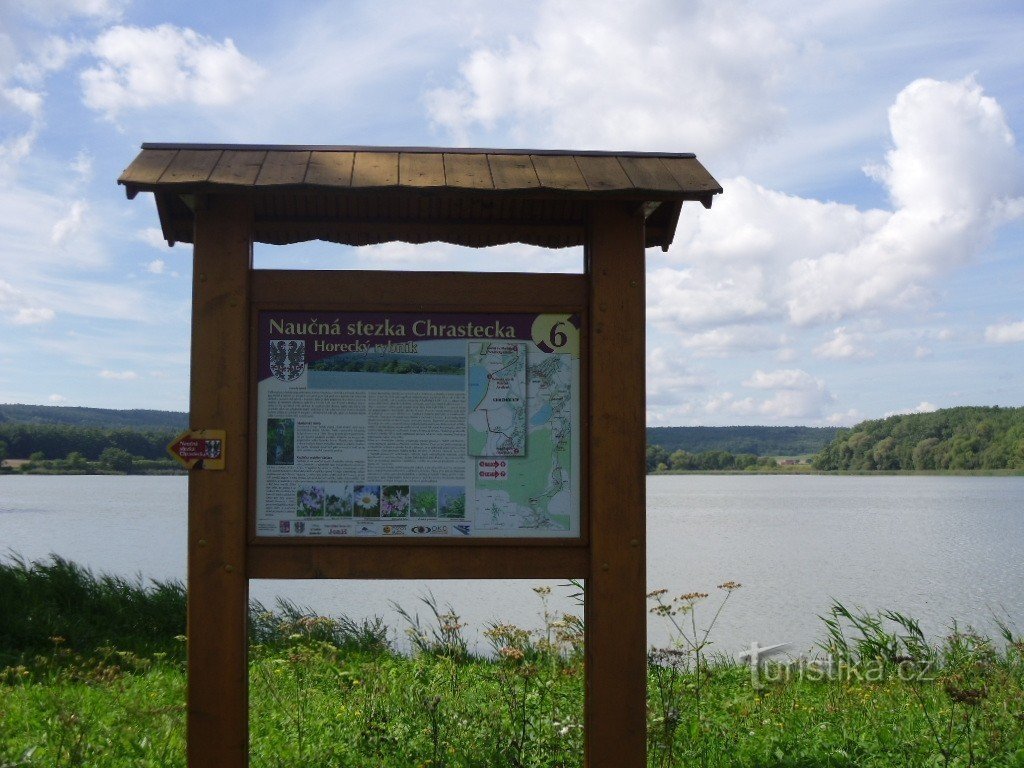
xmin=0 ymin=475 xmax=1024 ymax=653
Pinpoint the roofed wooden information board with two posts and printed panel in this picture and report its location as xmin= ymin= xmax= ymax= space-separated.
xmin=120 ymin=144 xmax=721 ymax=768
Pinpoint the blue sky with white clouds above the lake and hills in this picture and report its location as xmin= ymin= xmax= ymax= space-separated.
xmin=0 ymin=0 xmax=1024 ymax=426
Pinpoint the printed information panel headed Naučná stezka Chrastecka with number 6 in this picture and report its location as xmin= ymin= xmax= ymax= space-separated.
xmin=256 ymin=310 xmax=581 ymax=539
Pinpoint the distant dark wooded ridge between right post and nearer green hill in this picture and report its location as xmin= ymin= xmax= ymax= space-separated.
xmin=647 ymin=427 xmax=838 ymax=456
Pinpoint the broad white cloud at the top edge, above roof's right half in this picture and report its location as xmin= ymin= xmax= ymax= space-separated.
xmin=427 ymin=0 xmax=796 ymax=154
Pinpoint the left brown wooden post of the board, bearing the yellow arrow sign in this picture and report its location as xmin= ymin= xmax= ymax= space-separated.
xmin=187 ymin=196 xmax=252 ymax=768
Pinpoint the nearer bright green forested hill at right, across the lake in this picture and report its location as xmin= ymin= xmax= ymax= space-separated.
xmin=814 ymin=407 xmax=1024 ymax=470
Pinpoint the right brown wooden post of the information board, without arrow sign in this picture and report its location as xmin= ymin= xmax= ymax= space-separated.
xmin=585 ymin=202 xmax=647 ymax=768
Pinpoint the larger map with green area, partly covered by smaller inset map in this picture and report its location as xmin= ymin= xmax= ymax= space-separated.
xmin=476 ymin=353 xmax=572 ymax=530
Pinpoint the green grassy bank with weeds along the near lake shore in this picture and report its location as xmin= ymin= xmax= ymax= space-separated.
xmin=0 ymin=561 xmax=1024 ymax=768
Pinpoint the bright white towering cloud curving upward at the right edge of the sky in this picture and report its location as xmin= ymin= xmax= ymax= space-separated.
xmin=786 ymin=79 xmax=1022 ymax=325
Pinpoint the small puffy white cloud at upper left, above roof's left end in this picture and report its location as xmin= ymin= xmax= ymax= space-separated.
xmin=81 ymin=25 xmax=263 ymax=121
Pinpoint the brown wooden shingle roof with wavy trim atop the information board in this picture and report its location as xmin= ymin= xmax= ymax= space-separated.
xmin=118 ymin=143 xmax=722 ymax=249
